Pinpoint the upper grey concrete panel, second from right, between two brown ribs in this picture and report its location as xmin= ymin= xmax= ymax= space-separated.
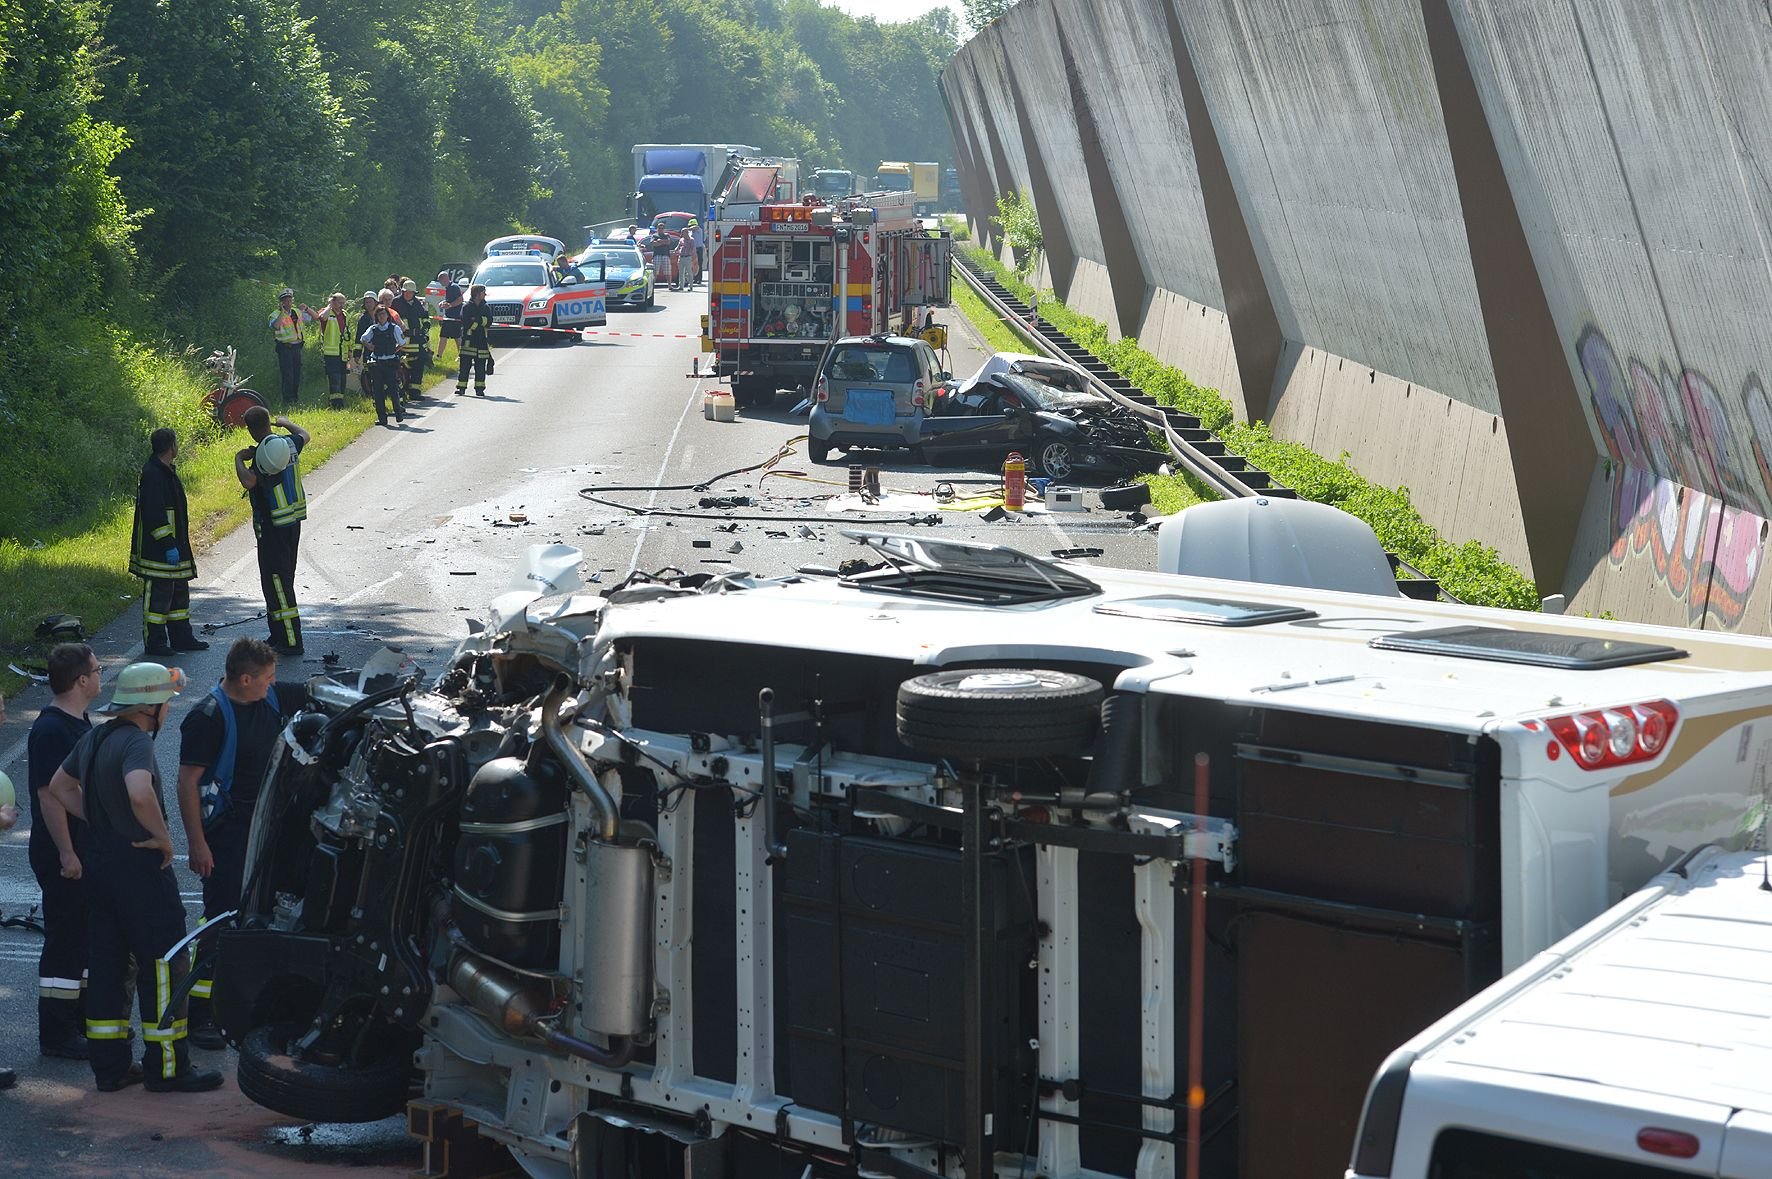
xmin=1177 ymin=0 xmax=1497 ymax=417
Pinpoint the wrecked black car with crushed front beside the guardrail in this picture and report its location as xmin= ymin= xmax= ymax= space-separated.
xmin=920 ymin=353 xmax=1166 ymax=480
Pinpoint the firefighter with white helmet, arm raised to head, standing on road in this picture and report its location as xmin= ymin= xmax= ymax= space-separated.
xmin=234 ymin=406 xmax=308 ymax=656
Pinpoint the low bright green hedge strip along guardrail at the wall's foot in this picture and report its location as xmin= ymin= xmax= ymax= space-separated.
xmin=968 ymin=250 xmax=1540 ymax=610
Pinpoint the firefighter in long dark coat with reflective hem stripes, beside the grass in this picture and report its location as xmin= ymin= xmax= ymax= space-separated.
xmin=129 ymin=426 xmax=209 ymax=658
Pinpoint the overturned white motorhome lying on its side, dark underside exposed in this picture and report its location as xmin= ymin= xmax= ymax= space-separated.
xmin=214 ymin=534 xmax=1772 ymax=1179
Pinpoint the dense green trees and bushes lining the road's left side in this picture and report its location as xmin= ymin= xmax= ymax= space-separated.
xmin=0 ymin=0 xmax=959 ymax=677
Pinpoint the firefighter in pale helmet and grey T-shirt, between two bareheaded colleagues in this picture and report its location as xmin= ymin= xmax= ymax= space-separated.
xmin=41 ymin=663 xmax=222 ymax=1092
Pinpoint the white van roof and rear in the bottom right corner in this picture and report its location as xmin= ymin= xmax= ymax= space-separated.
xmin=1347 ymin=849 xmax=1772 ymax=1179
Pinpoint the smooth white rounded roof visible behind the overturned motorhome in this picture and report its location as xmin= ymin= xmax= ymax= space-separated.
xmin=1157 ymin=495 xmax=1402 ymax=597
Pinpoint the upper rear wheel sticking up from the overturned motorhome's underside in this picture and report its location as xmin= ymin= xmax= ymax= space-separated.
xmin=898 ymin=667 xmax=1102 ymax=757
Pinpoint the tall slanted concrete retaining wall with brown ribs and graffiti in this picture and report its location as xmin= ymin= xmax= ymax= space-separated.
xmin=943 ymin=0 xmax=1772 ymax=633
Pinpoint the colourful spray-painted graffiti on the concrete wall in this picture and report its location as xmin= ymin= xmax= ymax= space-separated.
xmin=1575 ymin=328 xmax=1772 ymax=628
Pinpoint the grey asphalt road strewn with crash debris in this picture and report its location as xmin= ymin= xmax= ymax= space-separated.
xmin=0 ymin=280 xmax=1155 ymax=1177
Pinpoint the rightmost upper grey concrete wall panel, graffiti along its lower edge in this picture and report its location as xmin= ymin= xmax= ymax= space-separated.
xmin=1453 ymin=0 xmax=1772 ymax=514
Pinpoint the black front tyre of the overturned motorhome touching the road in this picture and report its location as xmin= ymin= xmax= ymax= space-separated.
xmin=236 ymin=1023 xmax=413 ymax=1122
